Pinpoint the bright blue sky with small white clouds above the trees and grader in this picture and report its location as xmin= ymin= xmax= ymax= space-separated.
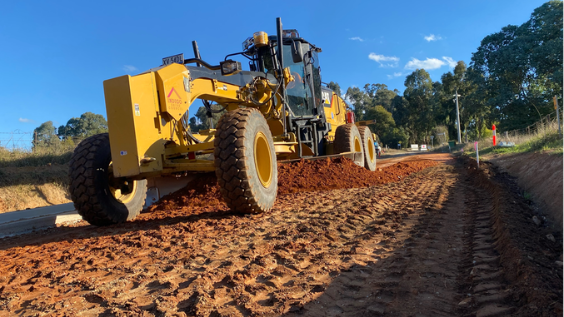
xmin=0 ymin=0 xmax=545 ymax=147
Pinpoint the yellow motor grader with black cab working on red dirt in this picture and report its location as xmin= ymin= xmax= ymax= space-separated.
xmin=70 ymin=18 xmax=376 ymax=226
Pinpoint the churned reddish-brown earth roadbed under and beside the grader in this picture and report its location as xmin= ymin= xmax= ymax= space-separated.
xmin=0 ymin=154 xmax=562 ymax=316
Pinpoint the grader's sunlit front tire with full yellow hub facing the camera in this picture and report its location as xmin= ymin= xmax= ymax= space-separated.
xmin=214 ymin=108 xmax=278 ymax=213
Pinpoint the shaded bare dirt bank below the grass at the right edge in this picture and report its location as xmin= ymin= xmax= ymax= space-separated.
xmin=490 ymin=153 xmax=563 ymax=228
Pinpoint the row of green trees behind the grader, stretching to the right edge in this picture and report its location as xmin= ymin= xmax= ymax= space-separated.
xmin=340 ymin=1 xmax=563 ymax=147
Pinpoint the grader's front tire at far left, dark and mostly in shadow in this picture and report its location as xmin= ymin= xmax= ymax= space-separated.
xmin=69 ymin=133 xmax=147 ymax=226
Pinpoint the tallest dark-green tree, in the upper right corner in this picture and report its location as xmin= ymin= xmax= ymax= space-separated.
xmin=470 ymin=1 xmax=563 ymax=130
